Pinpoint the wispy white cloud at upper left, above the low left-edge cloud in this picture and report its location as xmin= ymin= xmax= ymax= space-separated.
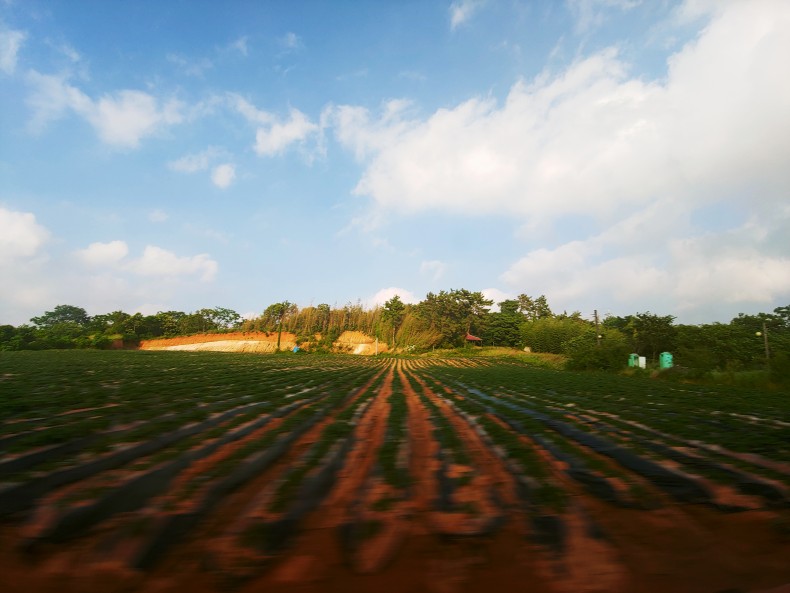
xmin=28 ymin=70 xmax=185 ymax=148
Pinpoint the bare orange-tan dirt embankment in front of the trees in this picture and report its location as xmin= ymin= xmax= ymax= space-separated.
xmin=140 ymin=331 xmax=388 ymax=355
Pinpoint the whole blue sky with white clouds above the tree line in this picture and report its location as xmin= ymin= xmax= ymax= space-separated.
xmin=0 ymin=0 xmax=790 ymax=325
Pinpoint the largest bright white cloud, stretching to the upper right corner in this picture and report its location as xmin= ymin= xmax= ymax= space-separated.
xmin=335 ymin=2 xmax=790 ymax=228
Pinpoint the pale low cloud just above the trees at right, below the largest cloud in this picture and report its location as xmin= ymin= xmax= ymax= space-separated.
xmin=502 ymin=206 xmax=790 ymax=322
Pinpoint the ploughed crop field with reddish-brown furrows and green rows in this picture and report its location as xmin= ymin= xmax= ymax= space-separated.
xmin=0 ymin=351 xmax=790 ymax=593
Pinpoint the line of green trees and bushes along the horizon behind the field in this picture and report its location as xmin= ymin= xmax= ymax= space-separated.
xmin=0 ymin=296 xmax=790 ymax=380
